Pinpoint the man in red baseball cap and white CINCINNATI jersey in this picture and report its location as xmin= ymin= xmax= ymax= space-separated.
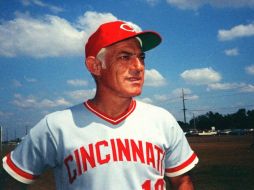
xmin=0 ymin=21 xmax=198 ymax=190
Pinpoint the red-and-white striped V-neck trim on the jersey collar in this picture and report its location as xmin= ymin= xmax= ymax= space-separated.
xmin=84 ymin=100 xmax=136 ymax=125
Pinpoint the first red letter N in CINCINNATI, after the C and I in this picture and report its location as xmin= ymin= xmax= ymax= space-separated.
xmin=80 ymin=144 xmax=96 ymax=172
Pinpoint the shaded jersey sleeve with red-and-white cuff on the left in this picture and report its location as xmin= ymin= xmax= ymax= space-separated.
xmin=3 ymin=118 xmax=57 ymax=184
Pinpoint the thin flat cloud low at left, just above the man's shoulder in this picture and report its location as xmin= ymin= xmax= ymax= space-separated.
xmin=12 ymin=94 xmax=71 ymax=108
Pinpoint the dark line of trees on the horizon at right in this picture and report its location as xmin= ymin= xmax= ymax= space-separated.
xmin=178 ymin=109 xmax=254 ymax=131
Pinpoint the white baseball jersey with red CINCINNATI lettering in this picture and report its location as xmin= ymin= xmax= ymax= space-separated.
xmin=3 ymin=100 xmax=198 ymax=190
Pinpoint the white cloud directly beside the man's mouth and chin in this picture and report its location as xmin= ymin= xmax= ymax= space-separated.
xmin=145 ymin=69 xmax=166 ymax=87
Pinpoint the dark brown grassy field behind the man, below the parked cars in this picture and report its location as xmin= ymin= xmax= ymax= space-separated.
xmin=0 ymin=136 xmax=254 ymax=190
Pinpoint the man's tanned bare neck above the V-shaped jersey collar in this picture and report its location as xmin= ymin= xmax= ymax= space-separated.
xmin=91 ymin=93 xmax=132 ymax=118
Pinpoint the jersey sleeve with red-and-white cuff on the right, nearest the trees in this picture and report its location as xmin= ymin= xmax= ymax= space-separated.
xmin=165 ymin=121 xmax=198 ymax=177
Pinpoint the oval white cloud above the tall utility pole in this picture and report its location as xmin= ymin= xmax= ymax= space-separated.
xmin=181 ymin=68 xmax=221 ymax=85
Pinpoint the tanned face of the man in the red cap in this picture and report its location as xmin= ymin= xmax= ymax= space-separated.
xmin=98 ymin=38 xmax=145 ymax=98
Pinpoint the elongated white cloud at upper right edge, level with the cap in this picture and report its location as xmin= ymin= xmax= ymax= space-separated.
xmin=218 ymin=24 xmax=254 ymax=41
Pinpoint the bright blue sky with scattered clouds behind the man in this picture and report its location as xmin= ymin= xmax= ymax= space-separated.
xmin=0 ymin=0 xmax=254 ymax=139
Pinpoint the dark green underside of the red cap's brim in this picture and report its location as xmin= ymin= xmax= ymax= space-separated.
xmin=136 ymin=31 xmax=162 ymax=51
